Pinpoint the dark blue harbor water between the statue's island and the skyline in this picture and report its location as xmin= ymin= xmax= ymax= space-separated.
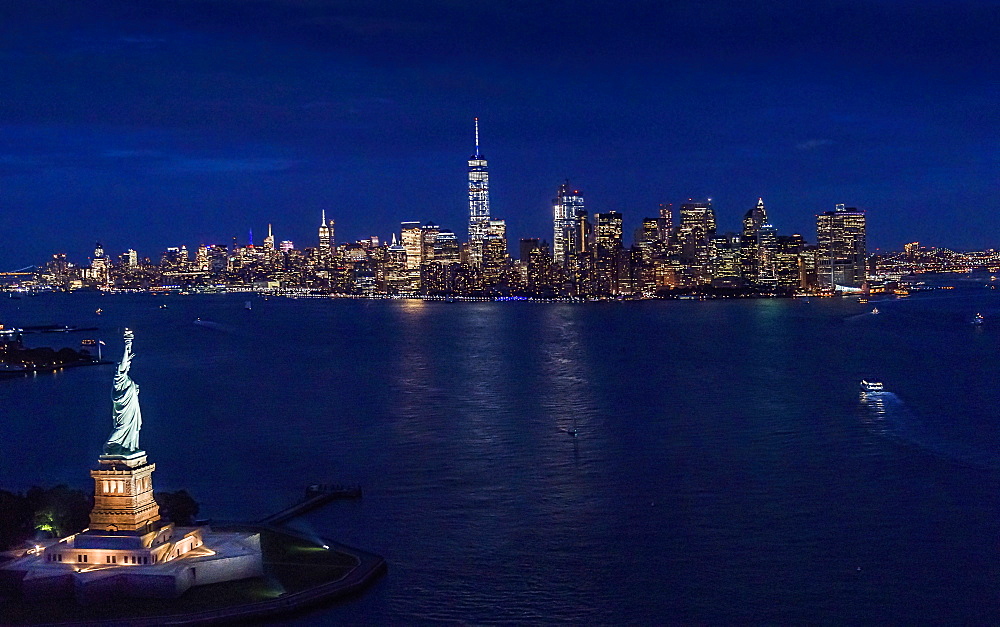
xmin=0 ymin=283 xmax=1000 ymax=624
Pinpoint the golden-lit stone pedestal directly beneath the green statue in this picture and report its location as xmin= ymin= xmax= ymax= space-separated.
xmin=90 ymin=451 xmax=160 ymax=533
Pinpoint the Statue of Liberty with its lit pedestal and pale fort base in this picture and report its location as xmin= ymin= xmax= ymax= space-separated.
xmin=2 ymin=329 xmax=263 ymax=601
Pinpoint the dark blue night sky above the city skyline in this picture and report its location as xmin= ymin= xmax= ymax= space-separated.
xmin=0 ymin=0 xmax=1000 ymax=270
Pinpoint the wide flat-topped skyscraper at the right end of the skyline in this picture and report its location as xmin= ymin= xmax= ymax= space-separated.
xmin=816 ymin=204 xmax=867 ymax=288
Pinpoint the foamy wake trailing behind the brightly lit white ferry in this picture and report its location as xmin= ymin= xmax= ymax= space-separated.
xmin=861 ymin=392 xmax=1000 ymax=470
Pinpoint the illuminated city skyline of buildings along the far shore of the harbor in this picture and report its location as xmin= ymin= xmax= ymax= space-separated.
xmin=21 ymin=118 xmax=968 ymax=299
